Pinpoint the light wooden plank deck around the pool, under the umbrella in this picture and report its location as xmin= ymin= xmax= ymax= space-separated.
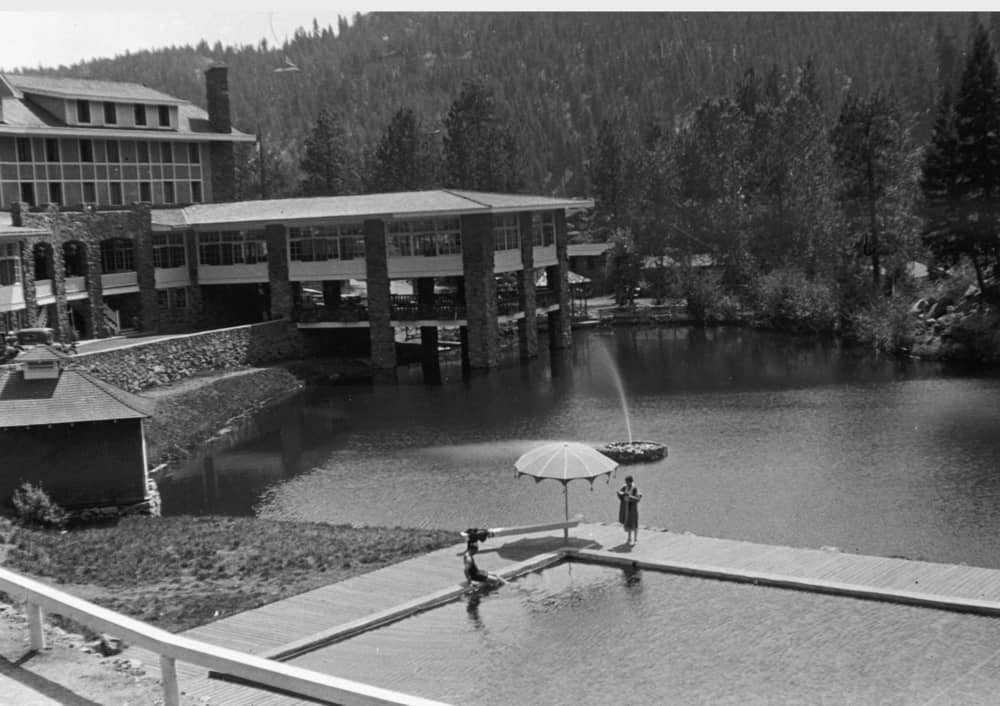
xmin=122 ymin=524 xmax=1000 ymax=706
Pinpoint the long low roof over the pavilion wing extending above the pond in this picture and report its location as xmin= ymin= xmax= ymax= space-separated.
xmin=152 ymin=190 xmax=594 ymax=230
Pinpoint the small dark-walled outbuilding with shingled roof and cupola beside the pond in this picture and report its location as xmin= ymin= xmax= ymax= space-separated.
xmin=0 ymin=346 xmax=150 ymax=509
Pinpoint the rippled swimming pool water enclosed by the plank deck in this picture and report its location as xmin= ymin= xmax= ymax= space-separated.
xmin=294 ymin=563 xmax=1000 ymax=706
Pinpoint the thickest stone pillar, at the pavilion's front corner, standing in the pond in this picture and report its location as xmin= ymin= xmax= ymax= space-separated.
xmin=462 ymin=214 xmax=500 ymax=368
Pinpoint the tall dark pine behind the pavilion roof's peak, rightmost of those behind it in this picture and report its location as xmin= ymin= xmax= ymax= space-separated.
xmin=443 ymin=82 xmax=522 ymax=191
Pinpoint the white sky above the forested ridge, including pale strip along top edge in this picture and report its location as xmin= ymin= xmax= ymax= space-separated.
xmin=0 ymin=0 xmax=989 ymax=70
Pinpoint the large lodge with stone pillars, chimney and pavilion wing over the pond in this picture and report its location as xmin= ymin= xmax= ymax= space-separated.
xmin=0 ymin=67 xmax=593 ymax=368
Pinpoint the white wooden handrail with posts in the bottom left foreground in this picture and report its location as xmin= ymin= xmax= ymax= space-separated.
xmin=0 ymin=568 xmax=445 ymax=706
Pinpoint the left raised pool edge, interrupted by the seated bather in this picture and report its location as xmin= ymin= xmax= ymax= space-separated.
xmin=260 ymin=550 xmax=567 ymax=662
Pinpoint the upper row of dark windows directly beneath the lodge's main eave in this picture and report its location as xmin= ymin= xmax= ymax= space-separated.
xmin=9 ymin=137 xmax=201 ymax=164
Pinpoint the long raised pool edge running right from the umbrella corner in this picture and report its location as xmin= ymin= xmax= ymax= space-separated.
xmin=560 ymin=547 xmax=1000 ymax=617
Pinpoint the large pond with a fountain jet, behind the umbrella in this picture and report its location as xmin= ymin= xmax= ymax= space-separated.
xmin=161 ymin=328 xmax=1000 ymax=568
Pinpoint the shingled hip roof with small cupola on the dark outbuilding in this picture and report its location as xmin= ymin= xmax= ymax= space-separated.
xmin=0 ymin=360 xmax=151 ymax=428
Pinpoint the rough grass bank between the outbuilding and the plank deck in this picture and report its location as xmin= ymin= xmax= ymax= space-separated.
xmin=0 ymin=517 xmax=462 ymax=632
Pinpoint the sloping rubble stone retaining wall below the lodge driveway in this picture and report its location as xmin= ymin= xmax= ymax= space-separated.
xmin=72 ymin=321 xmax=308 ymax=392
